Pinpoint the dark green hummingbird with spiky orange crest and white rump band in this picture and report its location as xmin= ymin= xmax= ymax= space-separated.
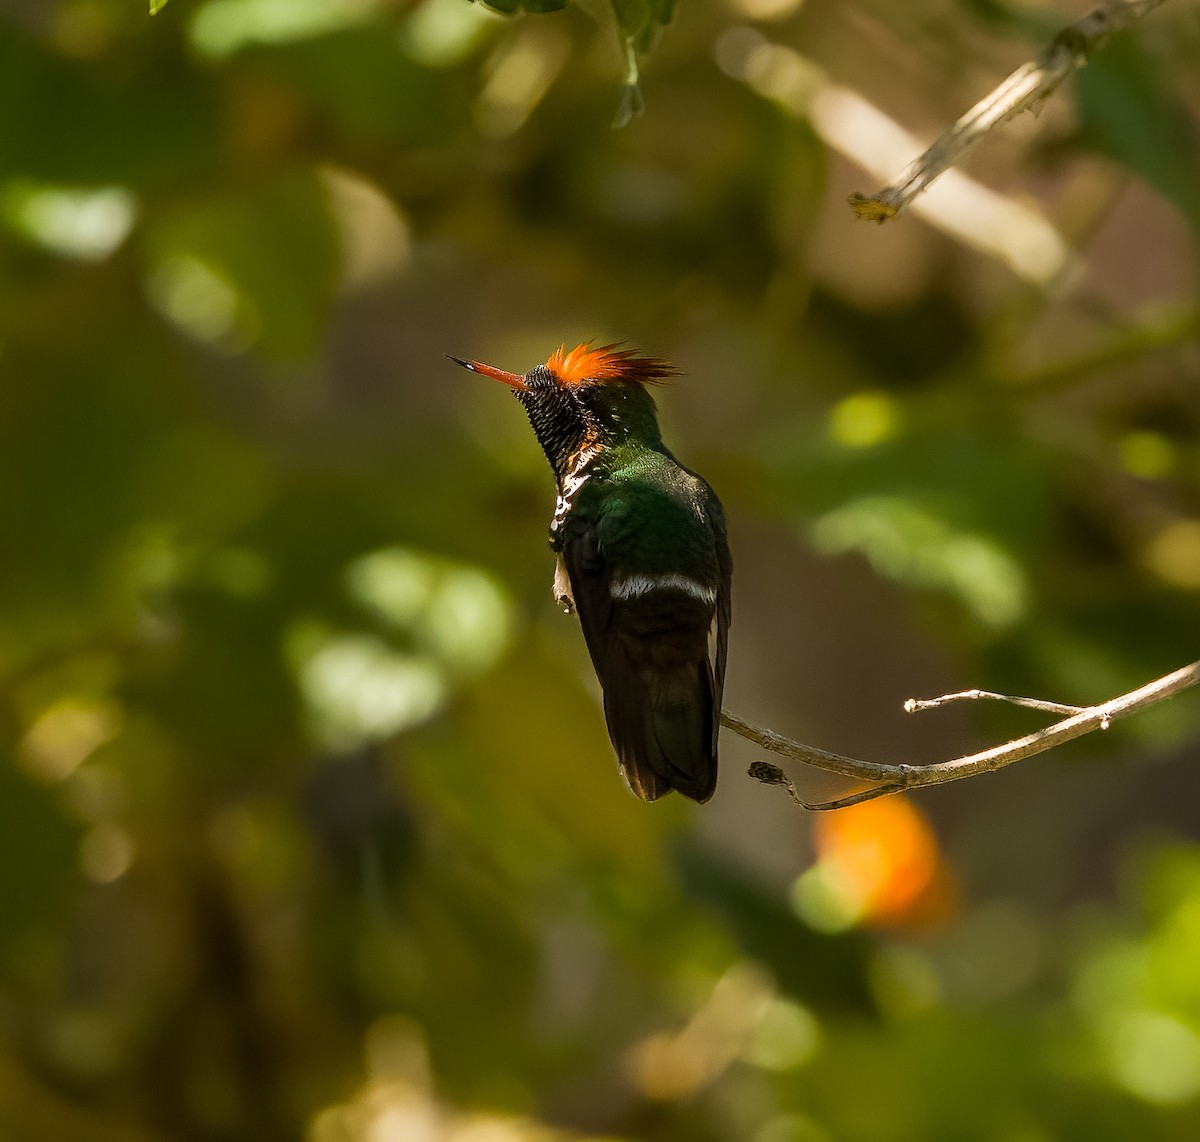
xmin=450 ymin=342 xmax=733 ymax=801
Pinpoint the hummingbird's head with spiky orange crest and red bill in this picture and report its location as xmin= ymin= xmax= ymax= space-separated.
xmin=450 ymin=343 xmax=678 ymax=480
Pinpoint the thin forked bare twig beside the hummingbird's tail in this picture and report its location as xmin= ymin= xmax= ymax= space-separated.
xmin=721 ymin=662 xmax=1200 ymax=810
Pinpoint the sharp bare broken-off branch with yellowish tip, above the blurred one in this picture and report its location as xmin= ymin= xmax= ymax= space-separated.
xmin=848 ymin=0 xmax=1164 ymax=222
